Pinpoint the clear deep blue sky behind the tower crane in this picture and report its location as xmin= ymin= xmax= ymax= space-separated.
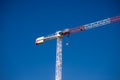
xmin=0 ymin=0 xmax=120 ymax=80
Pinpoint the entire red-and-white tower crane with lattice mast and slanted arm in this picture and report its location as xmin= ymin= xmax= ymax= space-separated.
xmin=35 ymin=16 xmax=120 ymax=80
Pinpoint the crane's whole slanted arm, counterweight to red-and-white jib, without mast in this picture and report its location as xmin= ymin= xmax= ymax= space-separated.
xmin=35 ymin=16 xmax=120 ymax=45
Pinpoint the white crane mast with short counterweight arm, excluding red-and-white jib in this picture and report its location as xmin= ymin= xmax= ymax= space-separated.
xmin=36 ymin=31 xmax=62 ymax=80
